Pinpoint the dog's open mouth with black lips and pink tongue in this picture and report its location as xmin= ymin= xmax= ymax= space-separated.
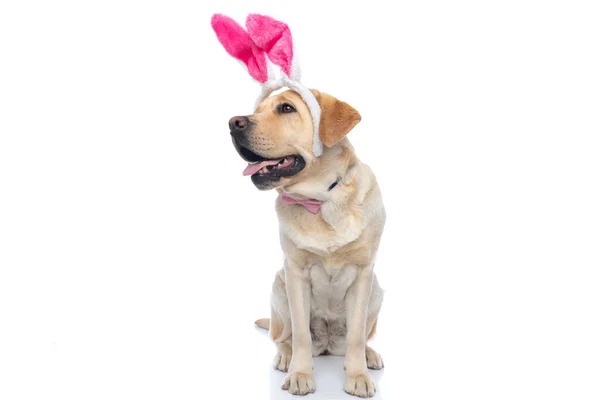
xmin=236 ymin=142 xmax=306 ymax=184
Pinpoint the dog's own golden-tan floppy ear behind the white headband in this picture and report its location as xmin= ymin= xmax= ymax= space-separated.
xmin=310 ymin=89 xmax=360 ymax=147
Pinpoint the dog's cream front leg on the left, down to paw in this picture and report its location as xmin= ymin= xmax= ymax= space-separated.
xmin=281 ymin=260 xmax=316 ymax=395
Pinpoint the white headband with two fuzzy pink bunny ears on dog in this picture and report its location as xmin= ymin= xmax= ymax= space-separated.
xmin=211 ymin=14 xmax=323 ymax=157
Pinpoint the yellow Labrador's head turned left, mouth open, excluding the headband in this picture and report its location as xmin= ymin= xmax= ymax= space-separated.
xmin=229 ymin=90 xmax=360 ymax=190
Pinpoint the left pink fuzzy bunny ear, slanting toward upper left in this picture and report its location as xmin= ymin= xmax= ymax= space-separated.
xmin=210 ymin=14 xmax=269 ymax=83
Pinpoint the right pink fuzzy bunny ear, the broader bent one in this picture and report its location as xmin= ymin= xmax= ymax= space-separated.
xmin=246 ymin=14 xmax=294 ymax=77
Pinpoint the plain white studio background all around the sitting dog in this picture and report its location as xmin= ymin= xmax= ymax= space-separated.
xmin=0 ymin=0 xmax=600 ymax=400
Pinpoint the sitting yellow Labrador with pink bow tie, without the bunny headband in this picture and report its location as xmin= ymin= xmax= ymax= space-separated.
xmin=229 ymin=89 xmax=385 ymax=397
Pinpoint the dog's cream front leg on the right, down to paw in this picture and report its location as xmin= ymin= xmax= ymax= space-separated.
xmin=344 ymin=265 xmax=375 ymax=397
